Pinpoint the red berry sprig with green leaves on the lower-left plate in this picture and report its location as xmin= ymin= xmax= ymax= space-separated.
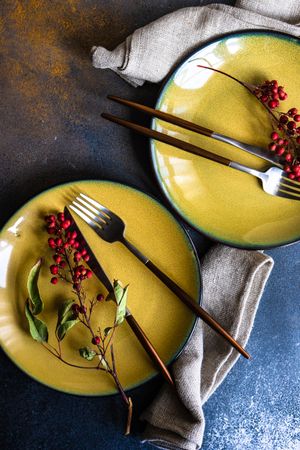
xmin=25 ymin=213 xmax=132 ymax=434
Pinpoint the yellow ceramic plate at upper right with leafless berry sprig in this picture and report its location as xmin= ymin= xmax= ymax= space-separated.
xmin=151 ymin=31 xmax=300 ymax=248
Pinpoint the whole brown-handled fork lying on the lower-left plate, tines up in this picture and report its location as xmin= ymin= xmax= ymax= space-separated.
xmin=70 ymin=193 xmax=250 ymax=359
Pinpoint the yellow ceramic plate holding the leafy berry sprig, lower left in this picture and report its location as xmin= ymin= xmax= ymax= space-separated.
xmin=0 ymin=181 xmax=200 ymax=395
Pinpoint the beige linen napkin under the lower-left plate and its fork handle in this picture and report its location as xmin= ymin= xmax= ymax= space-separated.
xmin=142 ymin=245 xmax=273 ymax=450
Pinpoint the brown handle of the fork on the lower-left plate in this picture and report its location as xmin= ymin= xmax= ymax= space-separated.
xmin=146 ymin=260 xmax=250 ymax=359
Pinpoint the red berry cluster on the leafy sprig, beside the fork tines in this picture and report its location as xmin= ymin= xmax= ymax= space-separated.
xmin=45 ymin=213 xmax=93 ymax=289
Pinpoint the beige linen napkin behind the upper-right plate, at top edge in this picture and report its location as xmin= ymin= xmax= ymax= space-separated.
xmin=92 ymin=0 xmax=300 ymax=86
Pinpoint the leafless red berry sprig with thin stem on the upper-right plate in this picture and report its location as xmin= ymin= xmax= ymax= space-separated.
xmin=198 ymin=65 xmax=300 ymax=181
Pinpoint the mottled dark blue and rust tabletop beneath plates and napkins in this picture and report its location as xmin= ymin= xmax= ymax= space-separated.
xmin=0 ymin=0 xmax=300 ymax=450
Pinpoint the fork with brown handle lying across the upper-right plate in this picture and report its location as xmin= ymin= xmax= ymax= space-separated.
xmin=102 ymin=113 xmax=300 ymax=200
